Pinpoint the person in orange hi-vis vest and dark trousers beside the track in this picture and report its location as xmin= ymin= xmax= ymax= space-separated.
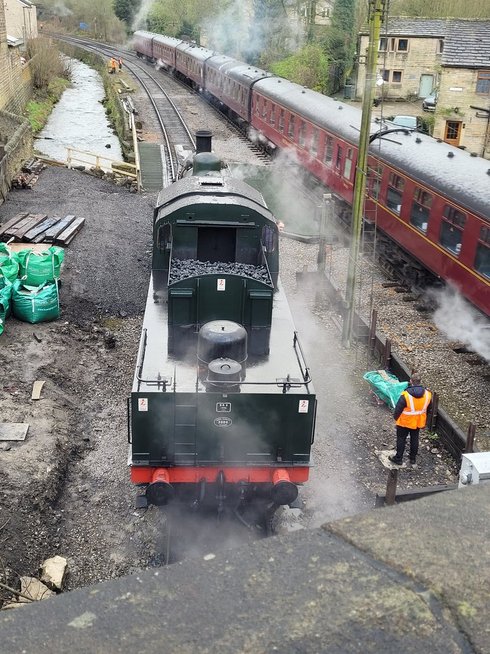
xmin=388 ymin=372 xmax=432 ymax=465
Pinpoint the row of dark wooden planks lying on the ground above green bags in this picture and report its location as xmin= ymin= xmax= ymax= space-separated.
xmin=0 ymin=213 xmax=85 ymax=246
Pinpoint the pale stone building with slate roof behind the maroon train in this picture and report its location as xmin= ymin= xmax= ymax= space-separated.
xmin=356 ymin=18 xmax=490 ymax=158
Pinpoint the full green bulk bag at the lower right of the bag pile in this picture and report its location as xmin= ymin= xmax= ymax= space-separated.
xmin=12 ymin=279 xmax=60 ymax=324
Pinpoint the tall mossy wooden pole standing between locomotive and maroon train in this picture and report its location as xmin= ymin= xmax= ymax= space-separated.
xmin=342 ymin=0 xmax=387 ymax=347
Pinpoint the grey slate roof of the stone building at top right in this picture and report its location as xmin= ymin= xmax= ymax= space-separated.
xmin=361 ymin=17 xmax=490 ymax=68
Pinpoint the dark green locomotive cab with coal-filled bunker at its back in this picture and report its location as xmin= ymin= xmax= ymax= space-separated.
xmin=152 ymin=158 xmax=279 ymax=355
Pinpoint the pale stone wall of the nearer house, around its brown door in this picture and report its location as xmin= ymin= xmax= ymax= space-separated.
xmin=433 ymin=66 xmax=490 ymax=159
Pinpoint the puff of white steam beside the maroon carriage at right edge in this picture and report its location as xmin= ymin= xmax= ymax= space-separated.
xmin=434 ymin=288 xmax=490 ymax=361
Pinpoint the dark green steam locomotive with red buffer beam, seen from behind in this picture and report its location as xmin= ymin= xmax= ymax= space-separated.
xmin=128 ymin=131 xmax=316 ymax=510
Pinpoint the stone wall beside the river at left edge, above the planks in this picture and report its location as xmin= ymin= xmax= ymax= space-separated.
xmin=0 ymin=111 xmax=33 ymax=204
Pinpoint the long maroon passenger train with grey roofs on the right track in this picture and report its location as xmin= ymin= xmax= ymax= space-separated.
xmin=134 ymin=31 xmax=490 ymax=316
